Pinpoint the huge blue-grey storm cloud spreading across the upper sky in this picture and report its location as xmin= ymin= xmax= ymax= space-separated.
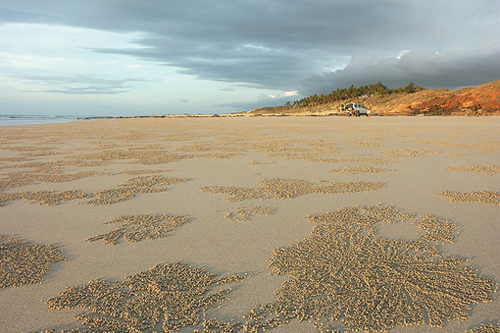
xmin=0 ymin=0 xmax=499 ymax=91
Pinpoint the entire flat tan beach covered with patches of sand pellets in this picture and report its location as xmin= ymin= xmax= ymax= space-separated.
xmin=0 ymin=117 xmax=500 ymax=332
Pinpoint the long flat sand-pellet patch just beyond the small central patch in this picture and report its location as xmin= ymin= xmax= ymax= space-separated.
xmin=201 ymin=178 xmax=385 ymax=201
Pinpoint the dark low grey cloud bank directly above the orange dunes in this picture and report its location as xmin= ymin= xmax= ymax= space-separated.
xmin=301 ymin=47 xmax=500 ymax=95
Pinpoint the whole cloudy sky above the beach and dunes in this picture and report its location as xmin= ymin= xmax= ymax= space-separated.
xmin=0 ymin=0 xmax=500 ymax=116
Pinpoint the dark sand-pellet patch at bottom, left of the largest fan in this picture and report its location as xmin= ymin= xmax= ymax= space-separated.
xmin=47 ymin=263 xmax=245 ymax=332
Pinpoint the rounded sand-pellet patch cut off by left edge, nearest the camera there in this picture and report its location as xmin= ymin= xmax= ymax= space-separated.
xmin=0 ymin=235 xmax=66 ymax=289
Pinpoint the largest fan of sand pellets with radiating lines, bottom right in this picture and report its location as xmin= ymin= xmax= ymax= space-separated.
xmin=242 ymin=207 xmax=497 ymax=332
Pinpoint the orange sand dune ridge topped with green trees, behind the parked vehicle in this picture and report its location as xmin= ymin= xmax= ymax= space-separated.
xmin=249 ymin=81 xmax=500 ymax=116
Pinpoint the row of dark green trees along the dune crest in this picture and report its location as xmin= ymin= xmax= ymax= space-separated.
xmin=285 ymin=82 xmax=425 ymax=109
